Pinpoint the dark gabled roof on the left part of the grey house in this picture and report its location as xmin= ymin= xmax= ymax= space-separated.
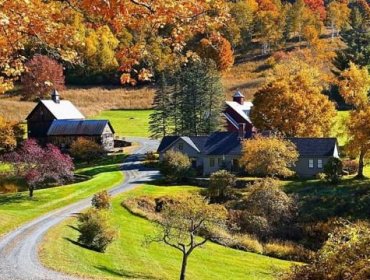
xmin=158 ymin=132 xmax=241 ymax=155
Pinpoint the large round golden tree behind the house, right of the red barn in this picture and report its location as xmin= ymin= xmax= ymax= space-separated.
xmin=251 ymin=58 xmax=336 ymax=137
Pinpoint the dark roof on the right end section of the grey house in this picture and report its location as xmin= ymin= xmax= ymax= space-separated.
xmin=288 ymin=138 xmax=337 ymax=157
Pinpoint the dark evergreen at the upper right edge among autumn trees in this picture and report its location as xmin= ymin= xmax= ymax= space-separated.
xmin=333 ymin=6 xmax=370 ymax=74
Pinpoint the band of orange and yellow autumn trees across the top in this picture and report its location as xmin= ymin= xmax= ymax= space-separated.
xmin=0 ymin=0 xmax=370 ymax=95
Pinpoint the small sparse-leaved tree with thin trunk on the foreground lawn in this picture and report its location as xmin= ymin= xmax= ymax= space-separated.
xmin=148 ymin=196 xmax=227 ymax=280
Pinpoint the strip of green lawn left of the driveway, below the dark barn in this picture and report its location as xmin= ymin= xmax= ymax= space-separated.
xmin=0 ymin=155 xmax=123 ymax=236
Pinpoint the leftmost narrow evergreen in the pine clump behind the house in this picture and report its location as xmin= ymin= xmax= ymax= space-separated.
xmin=149 ymin=72 xmax=172 ymax=138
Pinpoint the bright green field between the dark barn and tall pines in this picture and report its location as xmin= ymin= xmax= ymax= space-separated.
xmin=94 ymin=110 xmax=153 ymax=137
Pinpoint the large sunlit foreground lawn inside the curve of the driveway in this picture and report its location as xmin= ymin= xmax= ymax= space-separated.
xmin=40 ymin=185 xmax=291 ymax=280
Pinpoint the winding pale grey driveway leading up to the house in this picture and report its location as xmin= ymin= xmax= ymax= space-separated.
xmin=0 ymin=138 xmax=158 ymax=280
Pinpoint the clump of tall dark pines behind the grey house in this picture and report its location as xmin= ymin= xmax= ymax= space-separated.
xmin=150 ymin=61 xmax=225 ymax=138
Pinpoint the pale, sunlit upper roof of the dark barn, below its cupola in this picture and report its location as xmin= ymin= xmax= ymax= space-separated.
xmin=27 ymin=100 xmax=85 ymax=120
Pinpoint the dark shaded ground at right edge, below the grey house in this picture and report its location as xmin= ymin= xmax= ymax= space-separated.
xmin=285 ymin=178 xmax=370 ymax=221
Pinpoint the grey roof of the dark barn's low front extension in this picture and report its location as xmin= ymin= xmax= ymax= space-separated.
xmin=47 ymin=120 xmax=114 ymax=136
